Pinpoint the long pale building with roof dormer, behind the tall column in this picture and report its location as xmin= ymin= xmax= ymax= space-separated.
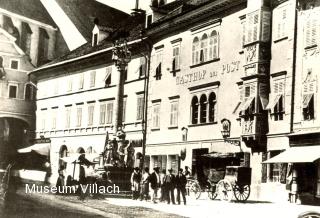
xmin=31 ymin=10 xmax=147 ymax=183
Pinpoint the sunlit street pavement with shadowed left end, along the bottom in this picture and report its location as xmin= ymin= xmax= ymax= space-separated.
xmin=0 ymin=187 xmax=320 ymax=218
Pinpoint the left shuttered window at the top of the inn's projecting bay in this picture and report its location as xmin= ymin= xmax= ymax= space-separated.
xmin=245 ymin=11 xmax=259 ymax=44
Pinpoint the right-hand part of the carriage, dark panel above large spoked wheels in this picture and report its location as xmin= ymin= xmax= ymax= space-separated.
xmin=216 ymin=166 xmax=251 ymax=202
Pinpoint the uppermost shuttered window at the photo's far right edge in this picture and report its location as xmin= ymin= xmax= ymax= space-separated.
xmin=304 ymin=14 xmax=319 ymax=47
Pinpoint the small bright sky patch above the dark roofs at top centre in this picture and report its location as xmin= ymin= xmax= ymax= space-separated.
xmin=97 ymin=0 xmax=151 ymax=14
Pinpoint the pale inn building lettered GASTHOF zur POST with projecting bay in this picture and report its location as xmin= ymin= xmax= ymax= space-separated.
xmin=146 ymin=0 xmax=271 ymax=201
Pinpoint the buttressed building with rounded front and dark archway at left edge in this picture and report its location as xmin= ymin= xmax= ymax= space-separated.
xmin=0 ymin=1 xmax=63 ymax=167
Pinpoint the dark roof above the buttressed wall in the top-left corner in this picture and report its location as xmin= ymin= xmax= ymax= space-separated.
xmin=0 ymin=0 xmax=56 ymax=27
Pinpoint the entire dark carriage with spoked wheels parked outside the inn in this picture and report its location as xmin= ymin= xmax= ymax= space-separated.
xmin=187 ymin=152 xmax=251 ymax=202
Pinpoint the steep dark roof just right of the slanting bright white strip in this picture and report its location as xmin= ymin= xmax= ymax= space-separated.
xmin=56 ymin=0 xmax=129 ymax=41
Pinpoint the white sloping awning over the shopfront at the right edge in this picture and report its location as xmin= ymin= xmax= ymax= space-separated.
xmin=263 ymin=145 xmax=320 ymax=163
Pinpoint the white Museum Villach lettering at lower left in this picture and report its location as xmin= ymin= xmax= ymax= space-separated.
xmin=25 ymin=184 xmax=120 ymax=194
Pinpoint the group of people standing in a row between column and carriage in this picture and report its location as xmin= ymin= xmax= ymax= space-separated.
xmin=131 ymin=167 xmax=190 ymax=205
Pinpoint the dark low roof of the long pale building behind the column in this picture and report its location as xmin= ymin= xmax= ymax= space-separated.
xmin=30 ymin=14 xmax=145 ymax=71
